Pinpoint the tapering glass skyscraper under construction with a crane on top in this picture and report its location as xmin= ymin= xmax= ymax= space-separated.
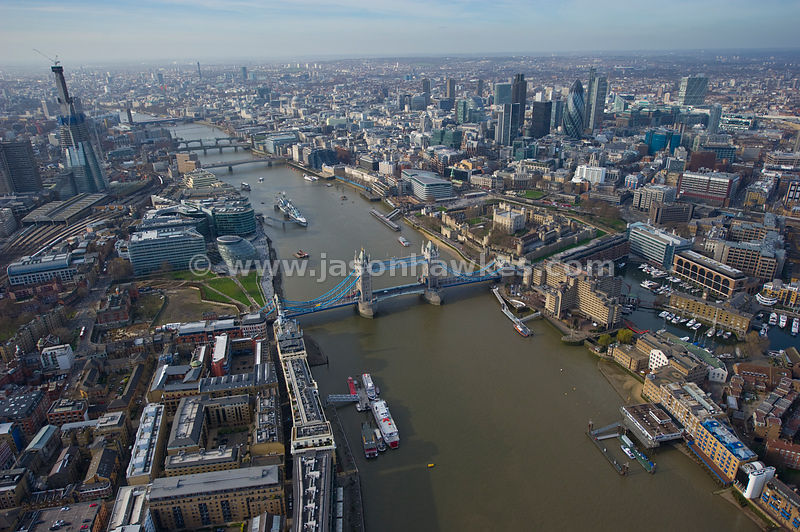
xmin=50 ymin=65 xmax=108 ymax=194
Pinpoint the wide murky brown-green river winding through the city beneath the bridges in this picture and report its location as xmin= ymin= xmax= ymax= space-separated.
xmin=169 ymin=124 xmax=757 ymax=531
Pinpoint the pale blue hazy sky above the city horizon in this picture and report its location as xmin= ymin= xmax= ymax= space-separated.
xmin=0 ymin=0 xmax=800 ymax=64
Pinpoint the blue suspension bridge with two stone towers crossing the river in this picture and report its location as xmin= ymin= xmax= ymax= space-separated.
xmin=262 ymin=241 xmax=517 ymax=318
